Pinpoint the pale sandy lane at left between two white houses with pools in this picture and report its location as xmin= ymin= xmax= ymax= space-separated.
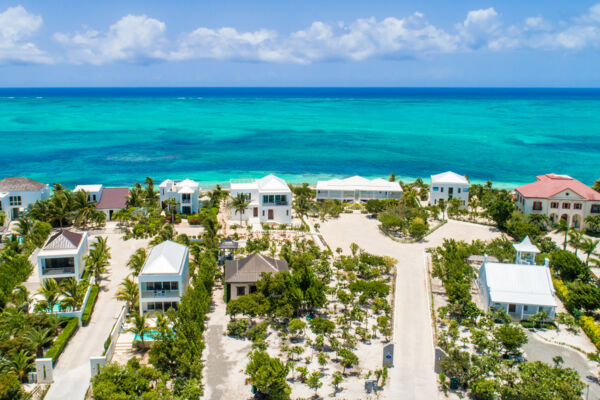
xmin=45 ymin=234 xmax=148 ymax=400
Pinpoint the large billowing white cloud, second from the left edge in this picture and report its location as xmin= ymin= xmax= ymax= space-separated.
xmin=54 ymin=15 xmax=167 ymax=65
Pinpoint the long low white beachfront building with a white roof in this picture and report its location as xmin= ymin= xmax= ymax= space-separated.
xmin=317 ymin=176 xmax=402 ymax=203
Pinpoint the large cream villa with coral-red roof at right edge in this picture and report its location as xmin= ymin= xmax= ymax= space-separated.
xmin=515 ymin=173 xmax=600 ymax=229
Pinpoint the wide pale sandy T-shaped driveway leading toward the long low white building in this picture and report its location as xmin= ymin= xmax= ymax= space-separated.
xmin=320 ymin=214 xmax=499 ymax=400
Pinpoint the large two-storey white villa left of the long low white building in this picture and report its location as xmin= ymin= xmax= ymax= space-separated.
xmin=230 ymin=175 xmax=292 ymax=225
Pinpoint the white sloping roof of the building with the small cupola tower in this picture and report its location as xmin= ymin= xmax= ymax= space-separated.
xmin=480 ymin=262 xmax=556 ymax=306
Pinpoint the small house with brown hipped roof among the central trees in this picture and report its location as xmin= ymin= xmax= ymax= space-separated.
xmin=225 ymin=254 xmax=289 ymax=300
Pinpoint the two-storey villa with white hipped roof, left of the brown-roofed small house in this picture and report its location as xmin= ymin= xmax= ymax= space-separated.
xmin=138 ymin=240 xmax=189 ymax=314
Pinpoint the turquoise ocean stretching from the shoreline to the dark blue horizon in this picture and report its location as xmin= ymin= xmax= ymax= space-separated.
xmin=0 ymin=88 xmax=600 ymax=188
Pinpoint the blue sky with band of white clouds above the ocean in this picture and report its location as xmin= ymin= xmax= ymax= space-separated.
xmin=0 ymin=0 xmax=600 ymax=87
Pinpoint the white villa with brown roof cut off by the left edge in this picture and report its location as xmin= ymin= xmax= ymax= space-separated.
xmin=0 ymin=176 xmax=50 ymax=225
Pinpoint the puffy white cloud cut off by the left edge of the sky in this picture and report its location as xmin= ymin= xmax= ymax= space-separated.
xmin=0 ymin=6 xmax=52 ymax=64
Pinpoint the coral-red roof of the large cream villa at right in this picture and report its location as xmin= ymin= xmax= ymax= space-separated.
xmin=515 ymin=173 xmax=600 ymax=201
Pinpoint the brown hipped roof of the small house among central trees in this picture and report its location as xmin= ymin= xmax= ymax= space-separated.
xmin=225 ymin=254 xmax=289 ymax=283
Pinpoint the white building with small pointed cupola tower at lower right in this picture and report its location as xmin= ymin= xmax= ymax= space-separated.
xmin=477 ymin=237 xmax=556 ymax=321
